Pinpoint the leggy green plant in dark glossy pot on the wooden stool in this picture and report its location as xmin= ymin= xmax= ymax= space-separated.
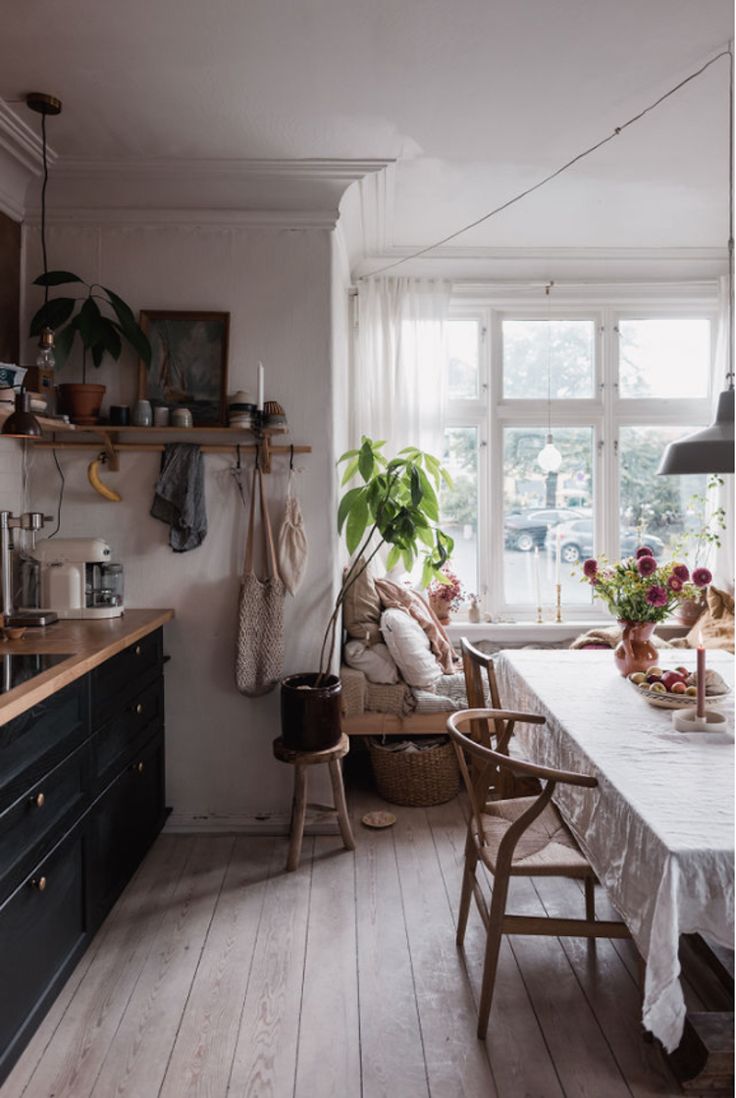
xmin=281 ymin=436 xmax=454 ymax=751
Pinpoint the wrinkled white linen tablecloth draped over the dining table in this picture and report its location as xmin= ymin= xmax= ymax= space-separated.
xmin=497 ymin=650 xmax=734 ymax=1051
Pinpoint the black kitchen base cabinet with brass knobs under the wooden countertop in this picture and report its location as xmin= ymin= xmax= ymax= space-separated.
xmin=0 ymin=629 xmax=166 ymax=1083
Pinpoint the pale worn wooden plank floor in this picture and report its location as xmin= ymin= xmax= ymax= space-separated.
xmin=0 ymin=791 xmax=680 ymax=1098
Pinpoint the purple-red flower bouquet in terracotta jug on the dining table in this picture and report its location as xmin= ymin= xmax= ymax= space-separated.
xmin=582 ymin=547 xmax=713 ymax=675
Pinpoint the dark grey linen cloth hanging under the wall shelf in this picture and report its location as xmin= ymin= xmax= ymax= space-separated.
xmin=150 ymin=442 xmax=207 ymax=552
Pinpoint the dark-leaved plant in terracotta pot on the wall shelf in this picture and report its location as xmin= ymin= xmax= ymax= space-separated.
xmin=30 ymin=271 xmax=150 ymax=425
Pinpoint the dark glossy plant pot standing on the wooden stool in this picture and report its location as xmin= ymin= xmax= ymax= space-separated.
xmin=281 ymin=672 xmax=343 ymax=751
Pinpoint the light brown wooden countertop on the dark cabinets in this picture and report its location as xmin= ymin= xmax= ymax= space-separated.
xmin=0 ymin=610 xmax=174 ymax=725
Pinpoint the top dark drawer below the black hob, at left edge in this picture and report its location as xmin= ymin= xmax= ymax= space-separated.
xmin=0 ymin=677 xmax=89 ymax=810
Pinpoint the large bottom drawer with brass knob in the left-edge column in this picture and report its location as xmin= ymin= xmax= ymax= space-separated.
xmin=0 ymin=830 xmax=86 ymax=1069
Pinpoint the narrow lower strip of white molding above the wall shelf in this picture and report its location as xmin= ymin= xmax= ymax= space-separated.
xmin=25 ymin=206 xmax=339 ymax=231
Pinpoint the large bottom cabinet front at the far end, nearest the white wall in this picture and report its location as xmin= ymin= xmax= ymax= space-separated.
xmin=87 ymin=732 xmax=165 ymax=930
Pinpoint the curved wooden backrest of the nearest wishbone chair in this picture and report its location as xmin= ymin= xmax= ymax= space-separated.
xmin=447 ymin=708 xmax=598 ymax=861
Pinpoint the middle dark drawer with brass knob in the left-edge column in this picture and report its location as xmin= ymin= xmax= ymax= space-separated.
xmin=0 ymin=744 xmax=89 ymax=898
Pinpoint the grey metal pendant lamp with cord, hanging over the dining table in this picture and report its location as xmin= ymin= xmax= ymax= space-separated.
xmin=657 ymin=48 xmax=734 ymax=477
